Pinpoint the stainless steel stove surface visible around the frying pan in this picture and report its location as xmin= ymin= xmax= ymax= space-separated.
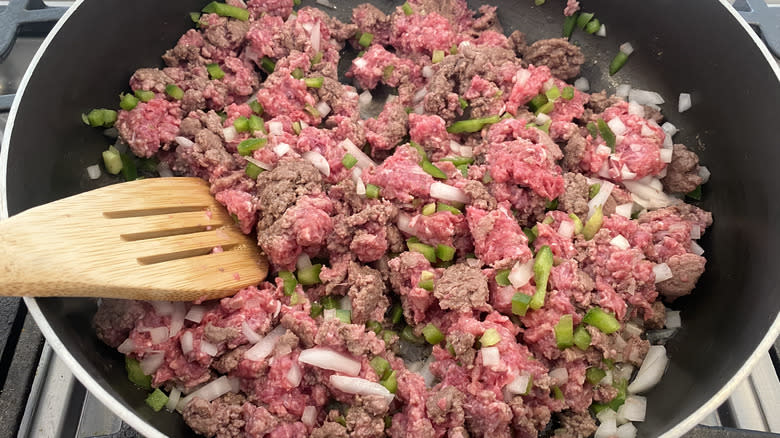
xmin=0 ymin=0 xmax=780 ymax=438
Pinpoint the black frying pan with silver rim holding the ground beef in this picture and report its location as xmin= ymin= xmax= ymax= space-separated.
xmin=0 ymin=0 xmax=780 ymax=437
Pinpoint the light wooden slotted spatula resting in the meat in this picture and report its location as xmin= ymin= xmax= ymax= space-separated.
xmin=0 ymin=178 xmax=268 ymax=301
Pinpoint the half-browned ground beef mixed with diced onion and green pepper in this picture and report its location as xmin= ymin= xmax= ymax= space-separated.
xmin=91 ymin=0 xmax=712 ymax=437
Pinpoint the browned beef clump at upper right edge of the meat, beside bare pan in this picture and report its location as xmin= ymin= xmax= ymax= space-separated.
xmin=523 ymin=38 xmax=585 ymax=80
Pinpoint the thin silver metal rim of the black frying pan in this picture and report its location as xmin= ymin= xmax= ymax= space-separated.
xmin=0 ymin=0 xmax=780 ymax=438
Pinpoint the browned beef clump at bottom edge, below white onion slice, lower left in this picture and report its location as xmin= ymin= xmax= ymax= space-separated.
xmin=182 ymin=396 xmax=246 ymax=438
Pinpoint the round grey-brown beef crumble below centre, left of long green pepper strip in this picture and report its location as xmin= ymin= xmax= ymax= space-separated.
xmin=433 ymin=263 xmax=489 ymax=312
